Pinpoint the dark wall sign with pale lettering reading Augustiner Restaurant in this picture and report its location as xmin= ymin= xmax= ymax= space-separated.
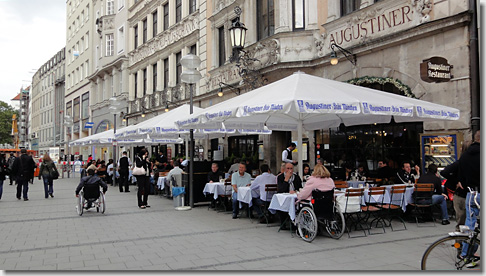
xmin=420 ymin=57 xmax=453 ymax=82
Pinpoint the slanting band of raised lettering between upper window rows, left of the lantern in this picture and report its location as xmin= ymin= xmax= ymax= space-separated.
xmin=129 ymin=16 xmax=199 ymax=66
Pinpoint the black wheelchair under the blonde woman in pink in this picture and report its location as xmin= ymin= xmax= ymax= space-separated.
xmin=295 ymin=189 xmax=346 ymax=242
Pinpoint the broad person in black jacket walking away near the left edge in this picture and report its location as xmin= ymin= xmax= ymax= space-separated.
xmin=12 ymin=149 xmax=36 ymax=201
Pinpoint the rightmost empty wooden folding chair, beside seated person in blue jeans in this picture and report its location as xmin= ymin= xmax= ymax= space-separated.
xmin=410 ymin=183 xmax=435 ymax=227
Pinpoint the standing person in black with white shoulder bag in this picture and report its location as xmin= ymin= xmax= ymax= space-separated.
xmin=133 ymin=149 xmax=150 ymax=209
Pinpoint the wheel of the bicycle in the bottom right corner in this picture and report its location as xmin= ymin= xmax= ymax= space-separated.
xmin=421 ymin=236 xmax=479 ymax=270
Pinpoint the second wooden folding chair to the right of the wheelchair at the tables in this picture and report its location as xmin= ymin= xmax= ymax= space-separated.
xmin=361 ymin=187 xmax=386 ymax=235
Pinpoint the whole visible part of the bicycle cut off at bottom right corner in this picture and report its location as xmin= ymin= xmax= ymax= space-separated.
xmin=421 ymin=188 xmax=481 ymax=270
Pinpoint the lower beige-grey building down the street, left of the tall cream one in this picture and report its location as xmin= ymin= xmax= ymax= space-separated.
xmin=28 ymin=48 xmax=66 ymax=155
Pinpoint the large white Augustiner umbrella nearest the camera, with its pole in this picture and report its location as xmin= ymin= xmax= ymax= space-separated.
xmin=176 ymin=72 xmax=460 ymax=175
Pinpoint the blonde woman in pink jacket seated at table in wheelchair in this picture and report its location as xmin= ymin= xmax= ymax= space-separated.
xmin=297 ymin=164 xmax=335 ymax=202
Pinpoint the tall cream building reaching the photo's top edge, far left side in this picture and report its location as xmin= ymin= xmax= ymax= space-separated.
xmin=63 ymin=0 xmax=96 ymax=160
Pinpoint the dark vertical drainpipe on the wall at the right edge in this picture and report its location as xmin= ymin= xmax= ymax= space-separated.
xmin=469 ymin=0 xmax=481 ymax=135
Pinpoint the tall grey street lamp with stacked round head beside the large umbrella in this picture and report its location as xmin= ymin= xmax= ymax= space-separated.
xmin=181 ymin=54 xmax=202 ymax=208
